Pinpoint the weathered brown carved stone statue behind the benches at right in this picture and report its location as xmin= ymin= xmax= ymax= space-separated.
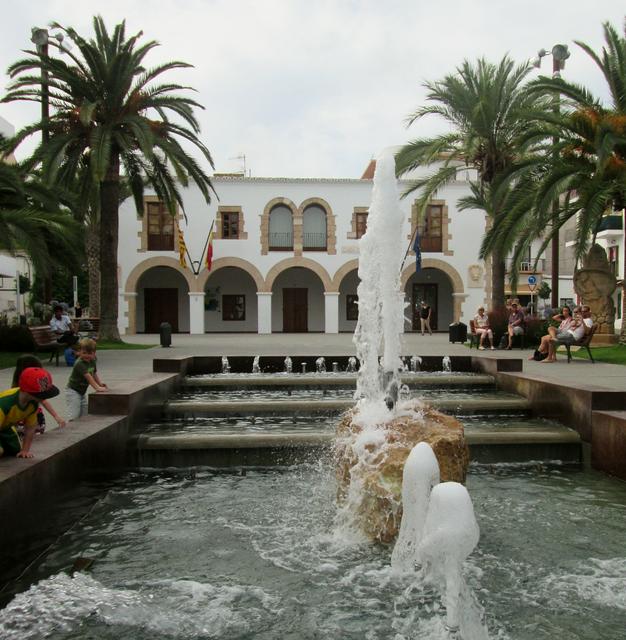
xmin=574 ymin=244 xmax=617 ymax=335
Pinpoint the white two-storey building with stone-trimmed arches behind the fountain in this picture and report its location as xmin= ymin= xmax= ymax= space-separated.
xmin=114 ymin=163 xmax=498 ymax=334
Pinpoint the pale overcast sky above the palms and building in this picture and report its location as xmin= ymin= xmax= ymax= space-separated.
xmin=0 ymin=0 xmax=626 ymax=178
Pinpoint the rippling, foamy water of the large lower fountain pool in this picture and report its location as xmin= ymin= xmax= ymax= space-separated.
xmin=0 ymin=461 xmax=626 ymax=640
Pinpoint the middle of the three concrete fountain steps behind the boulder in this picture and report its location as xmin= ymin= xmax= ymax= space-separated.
xmin=164 ymin=397 xmax=530 ymax=416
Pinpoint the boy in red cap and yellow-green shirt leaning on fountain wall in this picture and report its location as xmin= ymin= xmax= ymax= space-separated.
xmin=0 ymin=367 xmax=59 ymax=458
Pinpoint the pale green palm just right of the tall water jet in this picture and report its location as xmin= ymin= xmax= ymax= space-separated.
xmin=396 ymin=56 xmax=537 ymax=307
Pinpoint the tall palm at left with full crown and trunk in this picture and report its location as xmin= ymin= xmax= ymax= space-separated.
xmin=4 ymin=16 xmax=213 ymax=340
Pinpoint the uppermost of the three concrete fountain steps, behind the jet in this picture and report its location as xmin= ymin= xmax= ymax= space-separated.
xmin=183 ymin=372 xmax=495 ymax=390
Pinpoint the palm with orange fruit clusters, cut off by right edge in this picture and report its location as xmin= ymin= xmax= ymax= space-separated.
xmin=487 ymin=18 xmax=626 ymax=343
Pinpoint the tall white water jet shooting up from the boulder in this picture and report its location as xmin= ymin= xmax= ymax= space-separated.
xmin=353 ymin=153 xmax=404 ymax=411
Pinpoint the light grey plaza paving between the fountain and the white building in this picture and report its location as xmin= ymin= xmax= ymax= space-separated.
xmin=0 ymin=333 xmax=626 ymax=427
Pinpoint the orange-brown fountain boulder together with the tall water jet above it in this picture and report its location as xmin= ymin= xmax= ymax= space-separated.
xmin=335 ymin=150 xmax=469 ymax=542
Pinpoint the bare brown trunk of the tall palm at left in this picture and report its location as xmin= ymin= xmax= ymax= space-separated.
xmin=100 ymin=150 xmax=120 ymax=342
